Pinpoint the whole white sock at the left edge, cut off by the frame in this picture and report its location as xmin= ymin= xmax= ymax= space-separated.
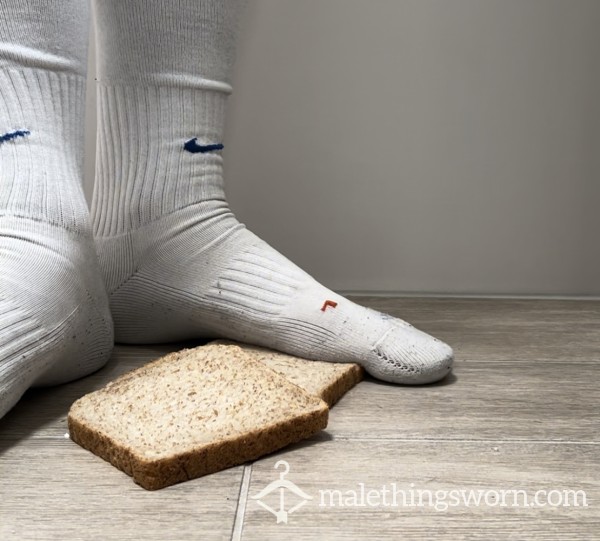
xmin=0 ymin=0 xmax=113 ymax=417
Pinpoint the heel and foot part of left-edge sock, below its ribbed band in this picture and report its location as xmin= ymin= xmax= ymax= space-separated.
xmin=0 ymin=211 xmax=113 ymax=417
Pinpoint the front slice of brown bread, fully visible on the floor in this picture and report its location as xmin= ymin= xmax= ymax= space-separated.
xmin=68 ymin=345 xmax=329 ymax=490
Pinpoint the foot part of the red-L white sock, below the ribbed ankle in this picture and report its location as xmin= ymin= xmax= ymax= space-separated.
xmin=96 ymin=201 xmax=452 ymax=383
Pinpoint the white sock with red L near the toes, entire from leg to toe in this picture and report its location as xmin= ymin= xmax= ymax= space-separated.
xmin=92 ymin=0 xmax=452 ymax=383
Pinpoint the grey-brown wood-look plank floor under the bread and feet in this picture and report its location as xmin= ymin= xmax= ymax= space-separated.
xmin=0 ymin=297 xmax=600 ymax=541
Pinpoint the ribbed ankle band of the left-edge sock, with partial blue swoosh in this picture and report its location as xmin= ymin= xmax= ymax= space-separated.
xmin=0 ymin=68 xmax=89 ymax=230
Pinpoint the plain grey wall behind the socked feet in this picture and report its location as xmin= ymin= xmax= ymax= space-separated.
xmin=86 ymin=0 xmax=600 ymax=295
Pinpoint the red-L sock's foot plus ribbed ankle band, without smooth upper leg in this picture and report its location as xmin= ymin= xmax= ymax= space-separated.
xmin=92 ymin=85 xmax=452 ymax=383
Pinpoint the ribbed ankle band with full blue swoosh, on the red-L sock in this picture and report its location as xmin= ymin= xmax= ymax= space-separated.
xmin=92 ymin=84 xmax=227 ymax=236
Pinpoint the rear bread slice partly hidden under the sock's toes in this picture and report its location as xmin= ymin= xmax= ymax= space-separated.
xmin=210 ymin=340 xmax=364 ymax=407
